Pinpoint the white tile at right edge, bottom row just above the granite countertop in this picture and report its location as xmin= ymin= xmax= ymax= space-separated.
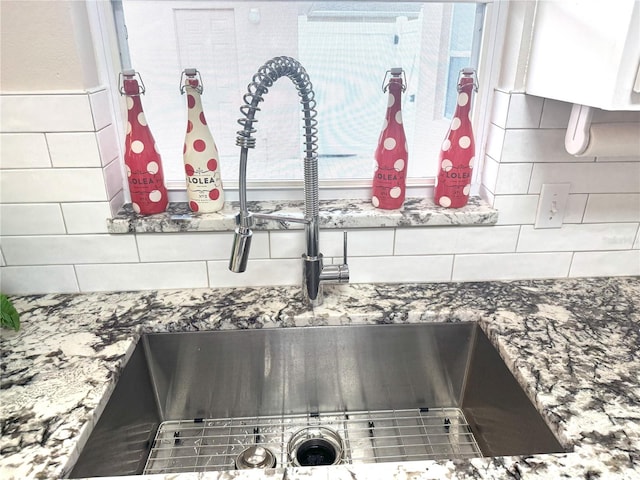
xmin=569 ymin=250 xmax=640 ymax=277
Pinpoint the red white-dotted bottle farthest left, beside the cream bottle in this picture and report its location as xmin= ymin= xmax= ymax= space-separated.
xmin=120 ymin=70 xmax=169 ymax=215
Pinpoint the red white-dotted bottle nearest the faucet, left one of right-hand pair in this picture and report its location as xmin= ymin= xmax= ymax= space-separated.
xmin=371 ymin=68 xmax=409 ymax=210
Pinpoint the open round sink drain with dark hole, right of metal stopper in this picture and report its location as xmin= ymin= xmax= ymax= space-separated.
xmin=288 ymin=427 xmax=344 ymax=467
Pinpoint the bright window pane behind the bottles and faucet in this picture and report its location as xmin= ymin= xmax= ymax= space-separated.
xmin=114 ymin=0 xmax=484 ymax=191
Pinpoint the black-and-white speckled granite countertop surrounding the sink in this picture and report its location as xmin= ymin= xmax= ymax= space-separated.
xmin=0 ymin=277 xmax=640 ymax=480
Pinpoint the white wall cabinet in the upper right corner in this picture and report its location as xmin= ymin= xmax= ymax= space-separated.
xmin=526 ymin=0 xmax=640 ymax=110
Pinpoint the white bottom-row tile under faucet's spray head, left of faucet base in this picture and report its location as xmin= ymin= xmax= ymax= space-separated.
xmin=207 ymin=258 xmax=302 ymax=287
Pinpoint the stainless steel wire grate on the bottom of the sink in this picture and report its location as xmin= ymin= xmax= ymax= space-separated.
xmin=144 ymin=408 xmax=482 ymax=474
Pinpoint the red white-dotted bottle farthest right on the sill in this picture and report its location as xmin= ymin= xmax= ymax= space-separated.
xmin=434 ymin=68 xmax=476 ymax=208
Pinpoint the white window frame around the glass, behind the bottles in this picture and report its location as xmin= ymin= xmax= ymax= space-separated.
xmin=102 ymin=0 xmax=506 ymax=202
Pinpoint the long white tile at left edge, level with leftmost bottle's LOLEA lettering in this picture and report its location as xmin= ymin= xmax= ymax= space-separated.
xmin=0 ymin=168 xmax=108 ymax=203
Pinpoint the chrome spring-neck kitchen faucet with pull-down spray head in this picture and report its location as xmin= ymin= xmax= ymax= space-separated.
xmin=229 ymin=57 xmax=349 ymax=306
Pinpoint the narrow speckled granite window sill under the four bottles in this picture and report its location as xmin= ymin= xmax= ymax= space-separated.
xmin=107 ymin=197 xmax=498 ymax=233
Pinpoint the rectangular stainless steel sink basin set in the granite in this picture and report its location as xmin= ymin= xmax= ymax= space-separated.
xmin=71 ymin=322 xmax=564 ymax=478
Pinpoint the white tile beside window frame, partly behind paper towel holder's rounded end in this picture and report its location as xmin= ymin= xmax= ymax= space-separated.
xmin=500 ymin=128 xmax=594 ymax=163
